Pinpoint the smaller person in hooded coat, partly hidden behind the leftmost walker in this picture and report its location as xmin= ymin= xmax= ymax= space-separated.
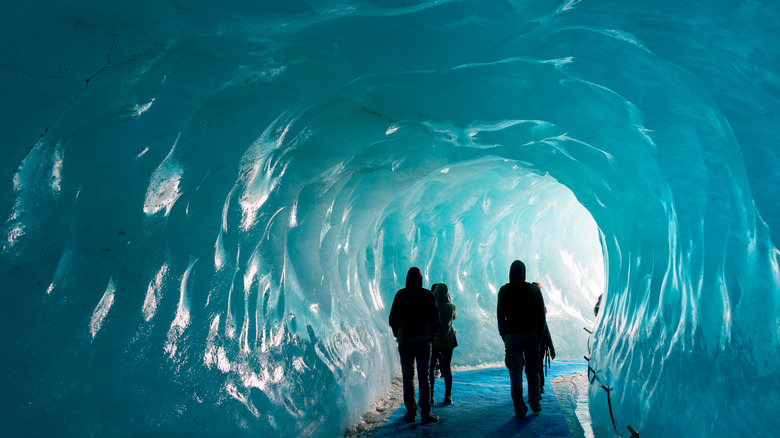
xmin=429 ymin=283 xmax=458 ymax=405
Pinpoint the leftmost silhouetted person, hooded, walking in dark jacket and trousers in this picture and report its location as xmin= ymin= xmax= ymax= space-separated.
xmin=390 ymin=268 xmax=439 ymax=424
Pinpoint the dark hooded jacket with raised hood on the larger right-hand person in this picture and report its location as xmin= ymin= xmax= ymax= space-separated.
xmin=496 ymin=260 xmax=546 ymax=341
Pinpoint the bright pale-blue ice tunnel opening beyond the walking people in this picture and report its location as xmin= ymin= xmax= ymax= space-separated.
xmin=366 ymin=157 xmax=605 ymax=365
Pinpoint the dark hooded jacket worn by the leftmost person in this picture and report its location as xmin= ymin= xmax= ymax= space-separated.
xmin=390 ymin=268 xmax=439 ymax=343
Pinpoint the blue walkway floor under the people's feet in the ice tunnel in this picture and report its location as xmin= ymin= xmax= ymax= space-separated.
xmin=374 ymin=361 xmax=586 ymax=438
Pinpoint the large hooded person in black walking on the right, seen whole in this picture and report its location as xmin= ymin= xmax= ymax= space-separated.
xmin=496 ymin=260 xmax=546 ymax=419
